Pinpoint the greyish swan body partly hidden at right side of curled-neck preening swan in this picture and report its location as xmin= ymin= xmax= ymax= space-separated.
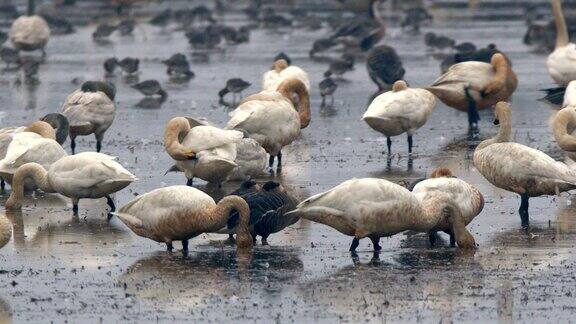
xmin=230 ymin=138 xmax=268 ymax=180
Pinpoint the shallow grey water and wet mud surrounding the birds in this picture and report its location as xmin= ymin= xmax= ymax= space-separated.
xmin=0 ymin=5 xmax=576 ymax=323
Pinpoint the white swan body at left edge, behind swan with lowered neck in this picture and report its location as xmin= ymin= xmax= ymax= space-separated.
xmin=0 ymin=132 xmax=68 ymax=190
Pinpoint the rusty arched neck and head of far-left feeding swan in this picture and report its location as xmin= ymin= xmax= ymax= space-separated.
xmin=6 ymin=162 xmax=54 ymax=210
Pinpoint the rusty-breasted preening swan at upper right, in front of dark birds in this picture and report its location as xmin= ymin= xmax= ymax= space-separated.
xmin=426 ymin=53 xmax=518 ymax=128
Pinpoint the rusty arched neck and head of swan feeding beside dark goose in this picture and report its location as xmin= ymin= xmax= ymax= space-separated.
xmin=211 ymin=196 xmax=252 ymax=250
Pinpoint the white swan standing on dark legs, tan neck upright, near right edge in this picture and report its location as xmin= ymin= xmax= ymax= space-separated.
xmin=474 ymin=102 xmax=576 ymax=227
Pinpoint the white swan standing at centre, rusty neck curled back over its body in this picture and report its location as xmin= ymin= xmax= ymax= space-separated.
xmin=226 ymin=78 xmax=310 ymax=169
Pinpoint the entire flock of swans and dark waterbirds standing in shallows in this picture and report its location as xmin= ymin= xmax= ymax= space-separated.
xmin=0 ymin=0 xmax=576 ymax=258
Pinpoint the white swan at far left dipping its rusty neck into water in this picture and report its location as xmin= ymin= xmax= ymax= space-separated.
xmin=6 ymin=152 xmax=136 ymax=214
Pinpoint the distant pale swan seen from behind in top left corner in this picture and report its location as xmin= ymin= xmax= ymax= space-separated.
xmin=8 ymin=0 xmax=50 ymax=54
